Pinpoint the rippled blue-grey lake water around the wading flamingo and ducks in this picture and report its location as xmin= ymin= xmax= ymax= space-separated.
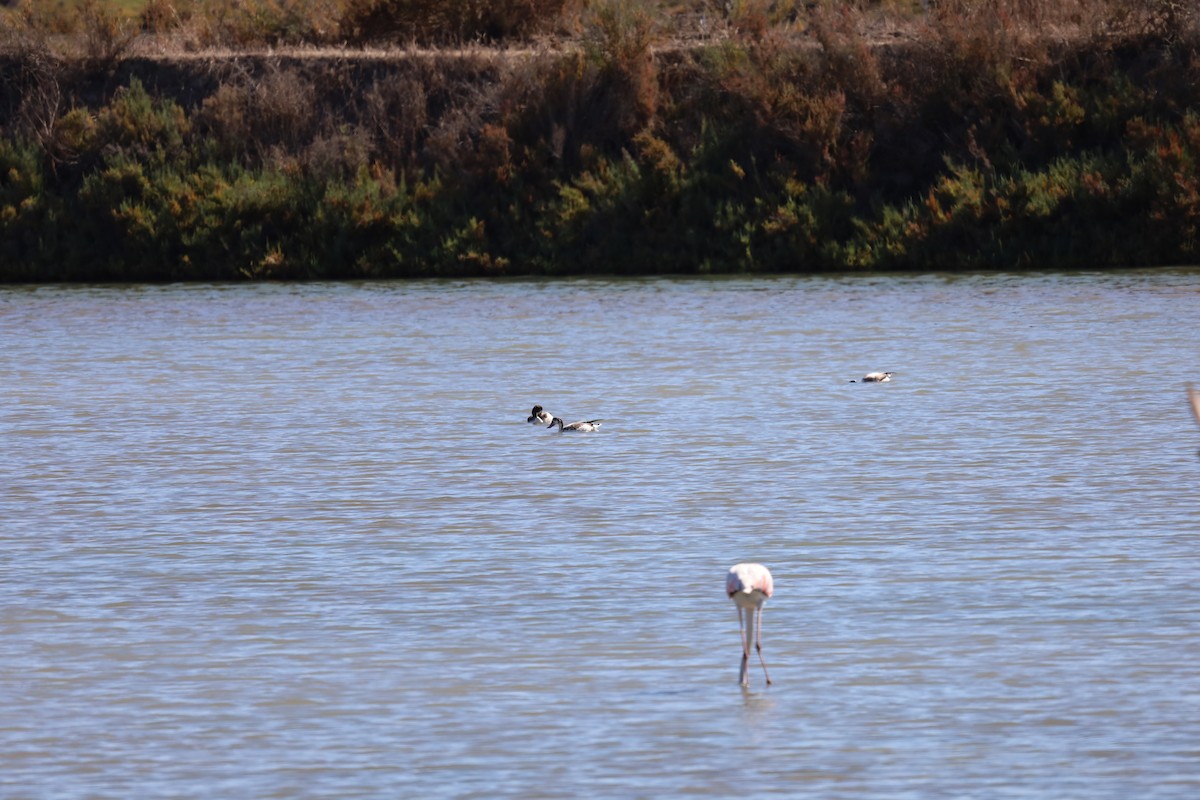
xmin=0 ymin=270 xmax=1200 ymax=800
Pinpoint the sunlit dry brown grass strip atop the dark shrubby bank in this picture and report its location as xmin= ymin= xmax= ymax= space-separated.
xmin=0 ymin=0 xmax=1200 ymax=65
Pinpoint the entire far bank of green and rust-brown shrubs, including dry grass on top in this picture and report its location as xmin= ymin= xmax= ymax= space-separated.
xmin=0 ymin=0 xmax=1200 ymax=283
